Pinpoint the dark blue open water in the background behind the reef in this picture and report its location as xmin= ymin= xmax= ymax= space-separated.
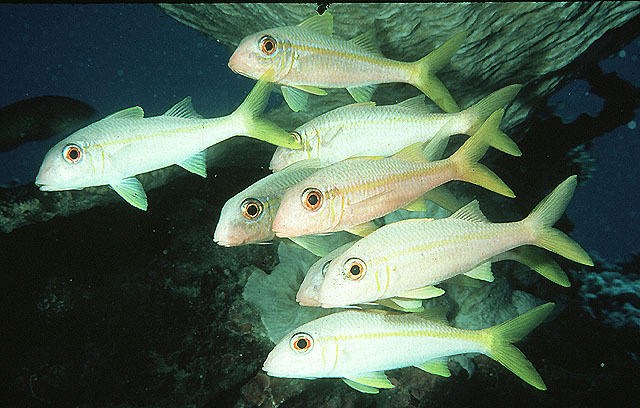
xmin=0 ymin=4 xmax=640 ymax=260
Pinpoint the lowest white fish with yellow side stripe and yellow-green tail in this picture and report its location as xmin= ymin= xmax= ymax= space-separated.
xmin=262 ymin=303 xmax=554 ymax=394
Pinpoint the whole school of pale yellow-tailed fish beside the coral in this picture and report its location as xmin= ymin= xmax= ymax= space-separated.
xmin=36 ymin=12 xmax=593 ymax=394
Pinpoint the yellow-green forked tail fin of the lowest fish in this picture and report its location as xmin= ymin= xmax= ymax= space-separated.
xmin=484 ymin=303 xmax=554 ymax=391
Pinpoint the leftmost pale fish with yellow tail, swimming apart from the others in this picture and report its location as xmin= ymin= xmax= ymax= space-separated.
xmin=35 ymin=72 xmax=301 ymax=210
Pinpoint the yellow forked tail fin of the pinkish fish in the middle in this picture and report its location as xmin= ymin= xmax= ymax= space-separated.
xmin=447 ymin=109 xmax=515 ymax=198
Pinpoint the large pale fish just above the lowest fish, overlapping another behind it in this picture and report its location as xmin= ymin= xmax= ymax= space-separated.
xmin=318 ymin=175 xmax=593 ymax=308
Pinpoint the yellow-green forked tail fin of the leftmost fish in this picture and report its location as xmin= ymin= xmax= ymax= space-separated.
xmin=233 ymin=68 xmax=302 ymax=149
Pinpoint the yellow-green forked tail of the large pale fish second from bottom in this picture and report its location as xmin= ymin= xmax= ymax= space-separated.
xmin=522 ymin=175 xmax=593 ymax=266
